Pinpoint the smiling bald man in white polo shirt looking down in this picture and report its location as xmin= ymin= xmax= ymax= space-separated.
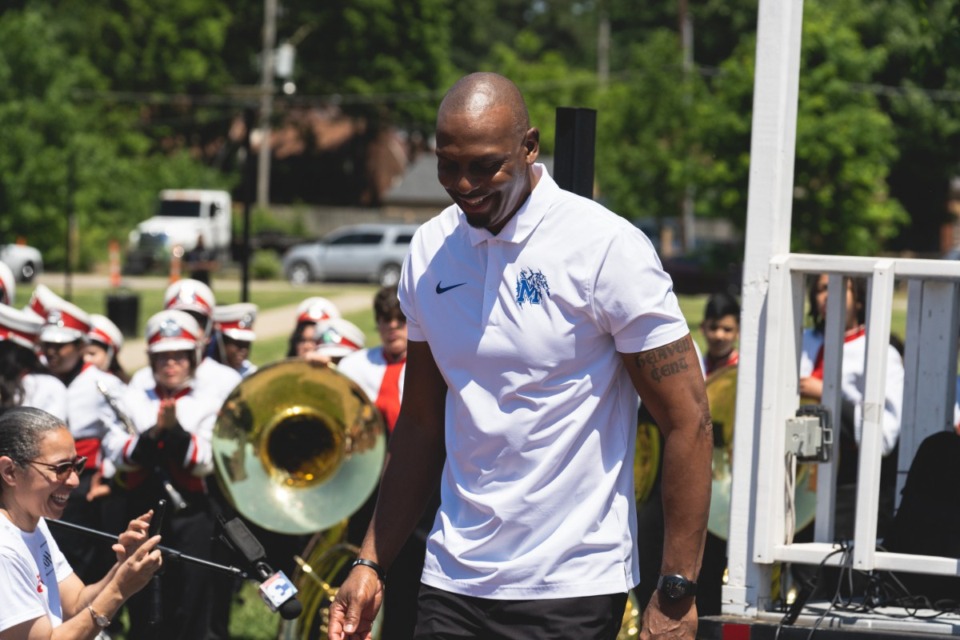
xmin=329 ymin=73 xmax=713 ymax=640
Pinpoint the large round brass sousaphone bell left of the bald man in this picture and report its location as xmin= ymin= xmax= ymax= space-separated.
xmin=213 ymin=359 xmax=386 ymax=535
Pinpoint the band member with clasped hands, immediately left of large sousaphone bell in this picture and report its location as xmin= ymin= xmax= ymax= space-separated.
xmin=104 ymin=310 xmax=222 ymax=638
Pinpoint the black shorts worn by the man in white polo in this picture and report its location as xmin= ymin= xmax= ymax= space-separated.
xmin=414 ymin=584 xmax=627 ymax=640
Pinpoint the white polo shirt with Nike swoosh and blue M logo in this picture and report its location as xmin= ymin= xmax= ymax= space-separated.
xmin=399 ymin=164 xmax=689 ymax=599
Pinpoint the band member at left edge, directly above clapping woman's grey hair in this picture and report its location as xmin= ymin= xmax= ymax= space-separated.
xmin=0 ymin=304 xmax=67 ymax=422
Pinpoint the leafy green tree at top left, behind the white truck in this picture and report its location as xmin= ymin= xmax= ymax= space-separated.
xmin=0 ymin=8 xmax=232 ymax=268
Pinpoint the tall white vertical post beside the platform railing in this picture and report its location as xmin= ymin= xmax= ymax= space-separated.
xmin=723 ymin=0 xmax=803 ymax=615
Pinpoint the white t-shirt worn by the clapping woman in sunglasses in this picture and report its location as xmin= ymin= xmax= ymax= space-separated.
xmin=0 ymin=515 xmax=73 ymax=632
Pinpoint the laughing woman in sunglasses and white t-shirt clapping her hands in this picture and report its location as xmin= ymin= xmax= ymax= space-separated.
xmin=0 ymin=407 xmax=161 ymax=640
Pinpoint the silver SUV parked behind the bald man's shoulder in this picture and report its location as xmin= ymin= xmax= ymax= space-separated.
xmin=283 ymin=223 xmax=419 ymax=286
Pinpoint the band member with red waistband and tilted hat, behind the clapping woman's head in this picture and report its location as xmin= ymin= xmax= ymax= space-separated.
xmin=30 ymin=285 xmax=129 ymax=582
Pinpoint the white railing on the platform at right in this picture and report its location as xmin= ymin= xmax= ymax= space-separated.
xmin=731 ymin=254 xmax=960 ymax=608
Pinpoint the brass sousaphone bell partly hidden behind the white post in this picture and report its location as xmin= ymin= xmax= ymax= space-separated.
xmin=706 ymin=365 xmax=817 ymax=540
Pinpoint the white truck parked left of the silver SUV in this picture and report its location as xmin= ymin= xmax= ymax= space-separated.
xmin=124 ymin=189 xmax=232 ymax=274
